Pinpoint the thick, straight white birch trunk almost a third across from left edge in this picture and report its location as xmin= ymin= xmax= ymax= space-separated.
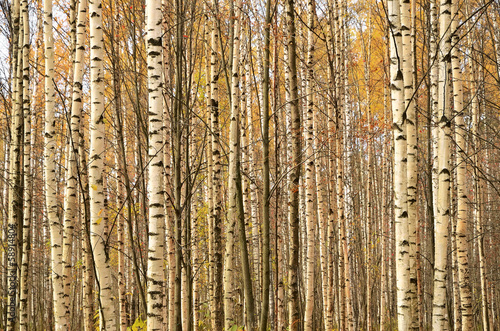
xmin=146 ymin=0 xmax=165 ymax=330
